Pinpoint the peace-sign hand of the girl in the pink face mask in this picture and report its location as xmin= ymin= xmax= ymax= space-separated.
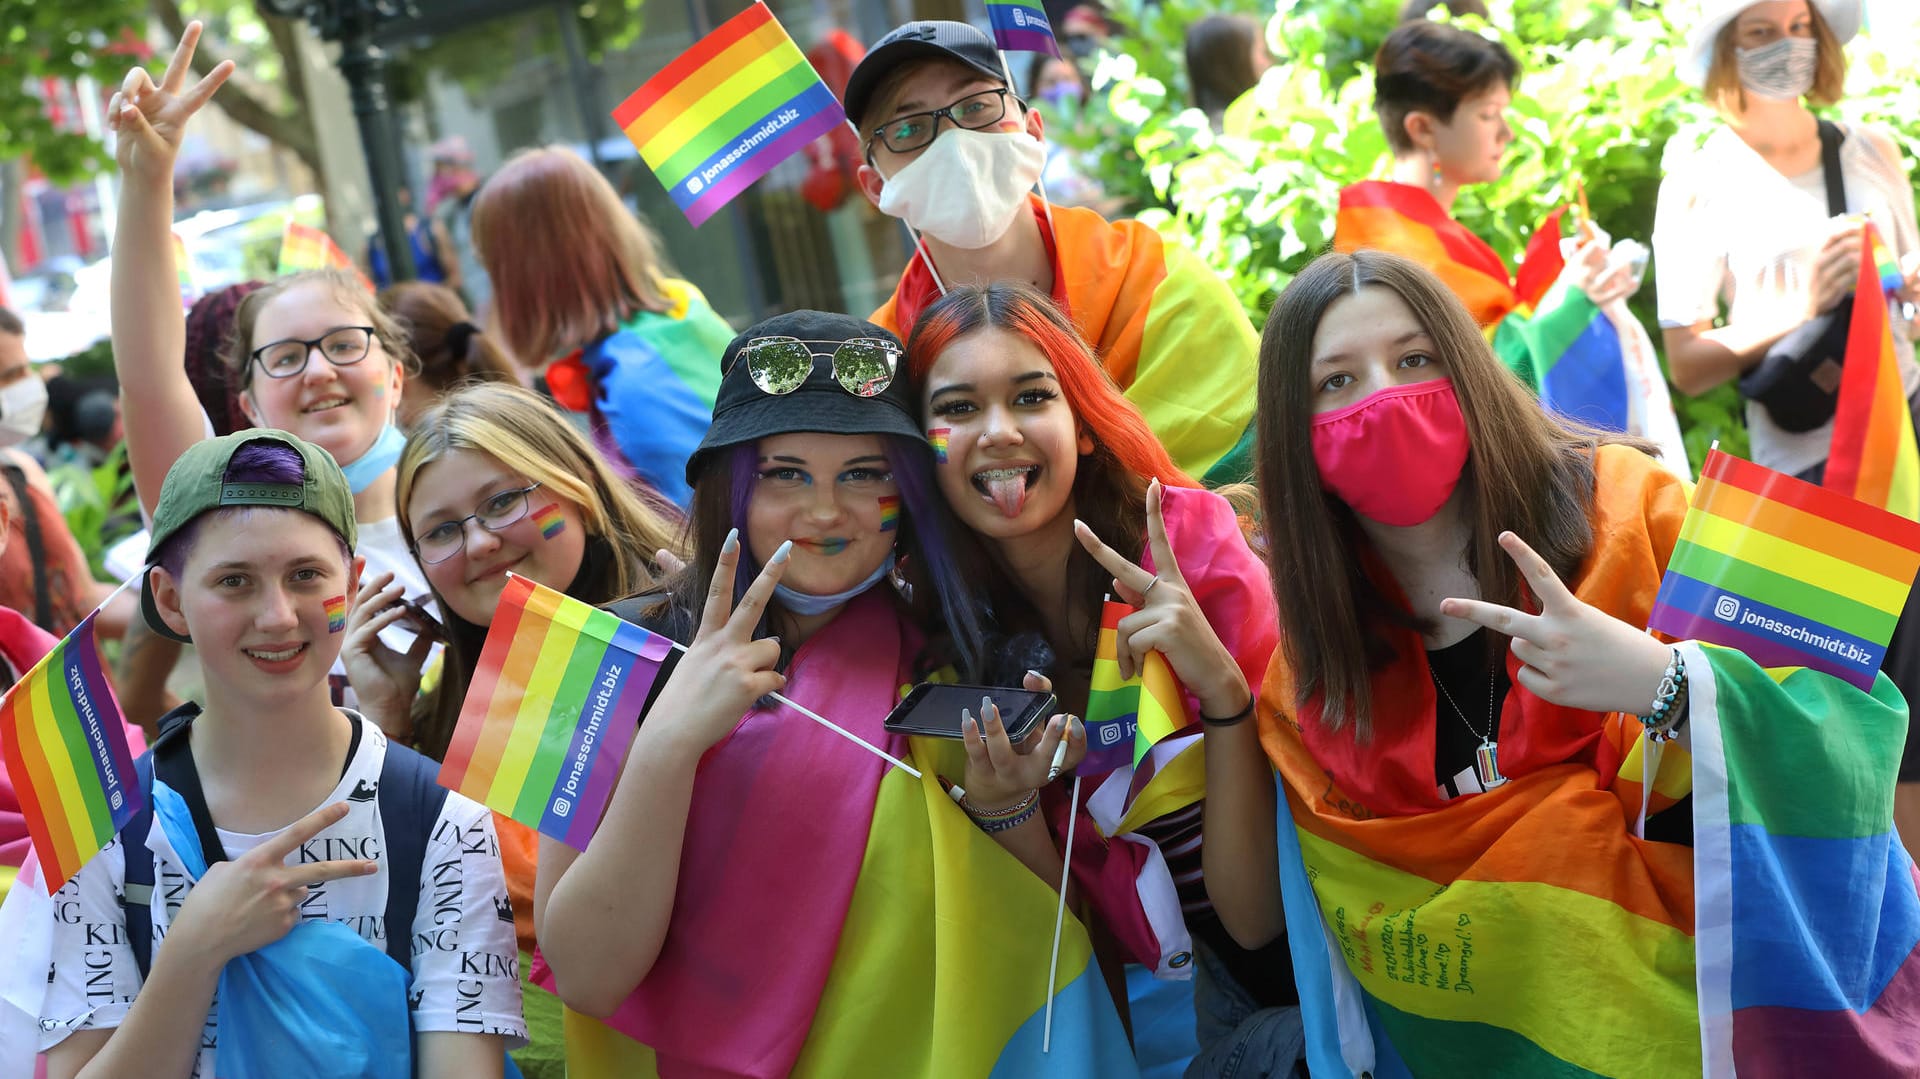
xmin=1440 ymin=532 xmax=1672 ymax=716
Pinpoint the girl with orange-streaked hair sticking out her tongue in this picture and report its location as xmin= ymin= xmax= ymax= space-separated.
xmin=906 ymin=282 xmax=1298 ymax=1075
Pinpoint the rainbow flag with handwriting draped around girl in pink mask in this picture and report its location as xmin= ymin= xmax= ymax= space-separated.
xmin=1260 ymin=447 xmax=1701 ymax=1075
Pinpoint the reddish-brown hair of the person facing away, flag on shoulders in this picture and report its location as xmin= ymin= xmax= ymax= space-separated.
xmin=472 ymin=146 xmax=672 ymax=362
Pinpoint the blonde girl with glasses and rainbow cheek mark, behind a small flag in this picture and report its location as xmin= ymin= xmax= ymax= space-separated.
xmin=340 ymin=382 xmax=682 ymax=1077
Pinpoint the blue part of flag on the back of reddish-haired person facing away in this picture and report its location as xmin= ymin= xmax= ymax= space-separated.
xmin=580 ymin=328 xmax=720 ymax=509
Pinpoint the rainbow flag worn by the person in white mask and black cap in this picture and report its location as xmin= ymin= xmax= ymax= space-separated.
xmin=872 ymin=198 xmax=1260 ymax=486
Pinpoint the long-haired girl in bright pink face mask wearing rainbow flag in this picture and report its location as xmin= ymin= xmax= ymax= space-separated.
xmin=1206 ymin=252 xmax=1910 ymax=1075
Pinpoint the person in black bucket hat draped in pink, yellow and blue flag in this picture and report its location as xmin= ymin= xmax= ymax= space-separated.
xmin=534 ymin=311 xmax=1135 ymax=1079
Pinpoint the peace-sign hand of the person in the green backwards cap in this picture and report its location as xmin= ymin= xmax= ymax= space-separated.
xmin=167 ymin=803 xmax=380 ymax=966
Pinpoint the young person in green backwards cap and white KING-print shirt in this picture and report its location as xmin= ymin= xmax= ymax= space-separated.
xmin=4 ymin=428 xmax=524 ymax=1079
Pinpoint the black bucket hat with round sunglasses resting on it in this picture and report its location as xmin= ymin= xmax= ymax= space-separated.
xmin=687 ymin=311 xmax=927 ymax=484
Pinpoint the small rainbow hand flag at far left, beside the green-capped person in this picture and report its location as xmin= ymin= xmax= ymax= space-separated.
xmin=0 ymin=611 xmax=146 ymax=895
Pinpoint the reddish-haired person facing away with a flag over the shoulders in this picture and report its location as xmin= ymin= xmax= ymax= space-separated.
xmin=472 ymin=146 xmax=733 ymax=509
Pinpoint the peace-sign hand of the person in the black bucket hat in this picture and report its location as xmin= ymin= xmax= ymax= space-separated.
xmin=647 ymin=530 xmax=793 ymax=756
